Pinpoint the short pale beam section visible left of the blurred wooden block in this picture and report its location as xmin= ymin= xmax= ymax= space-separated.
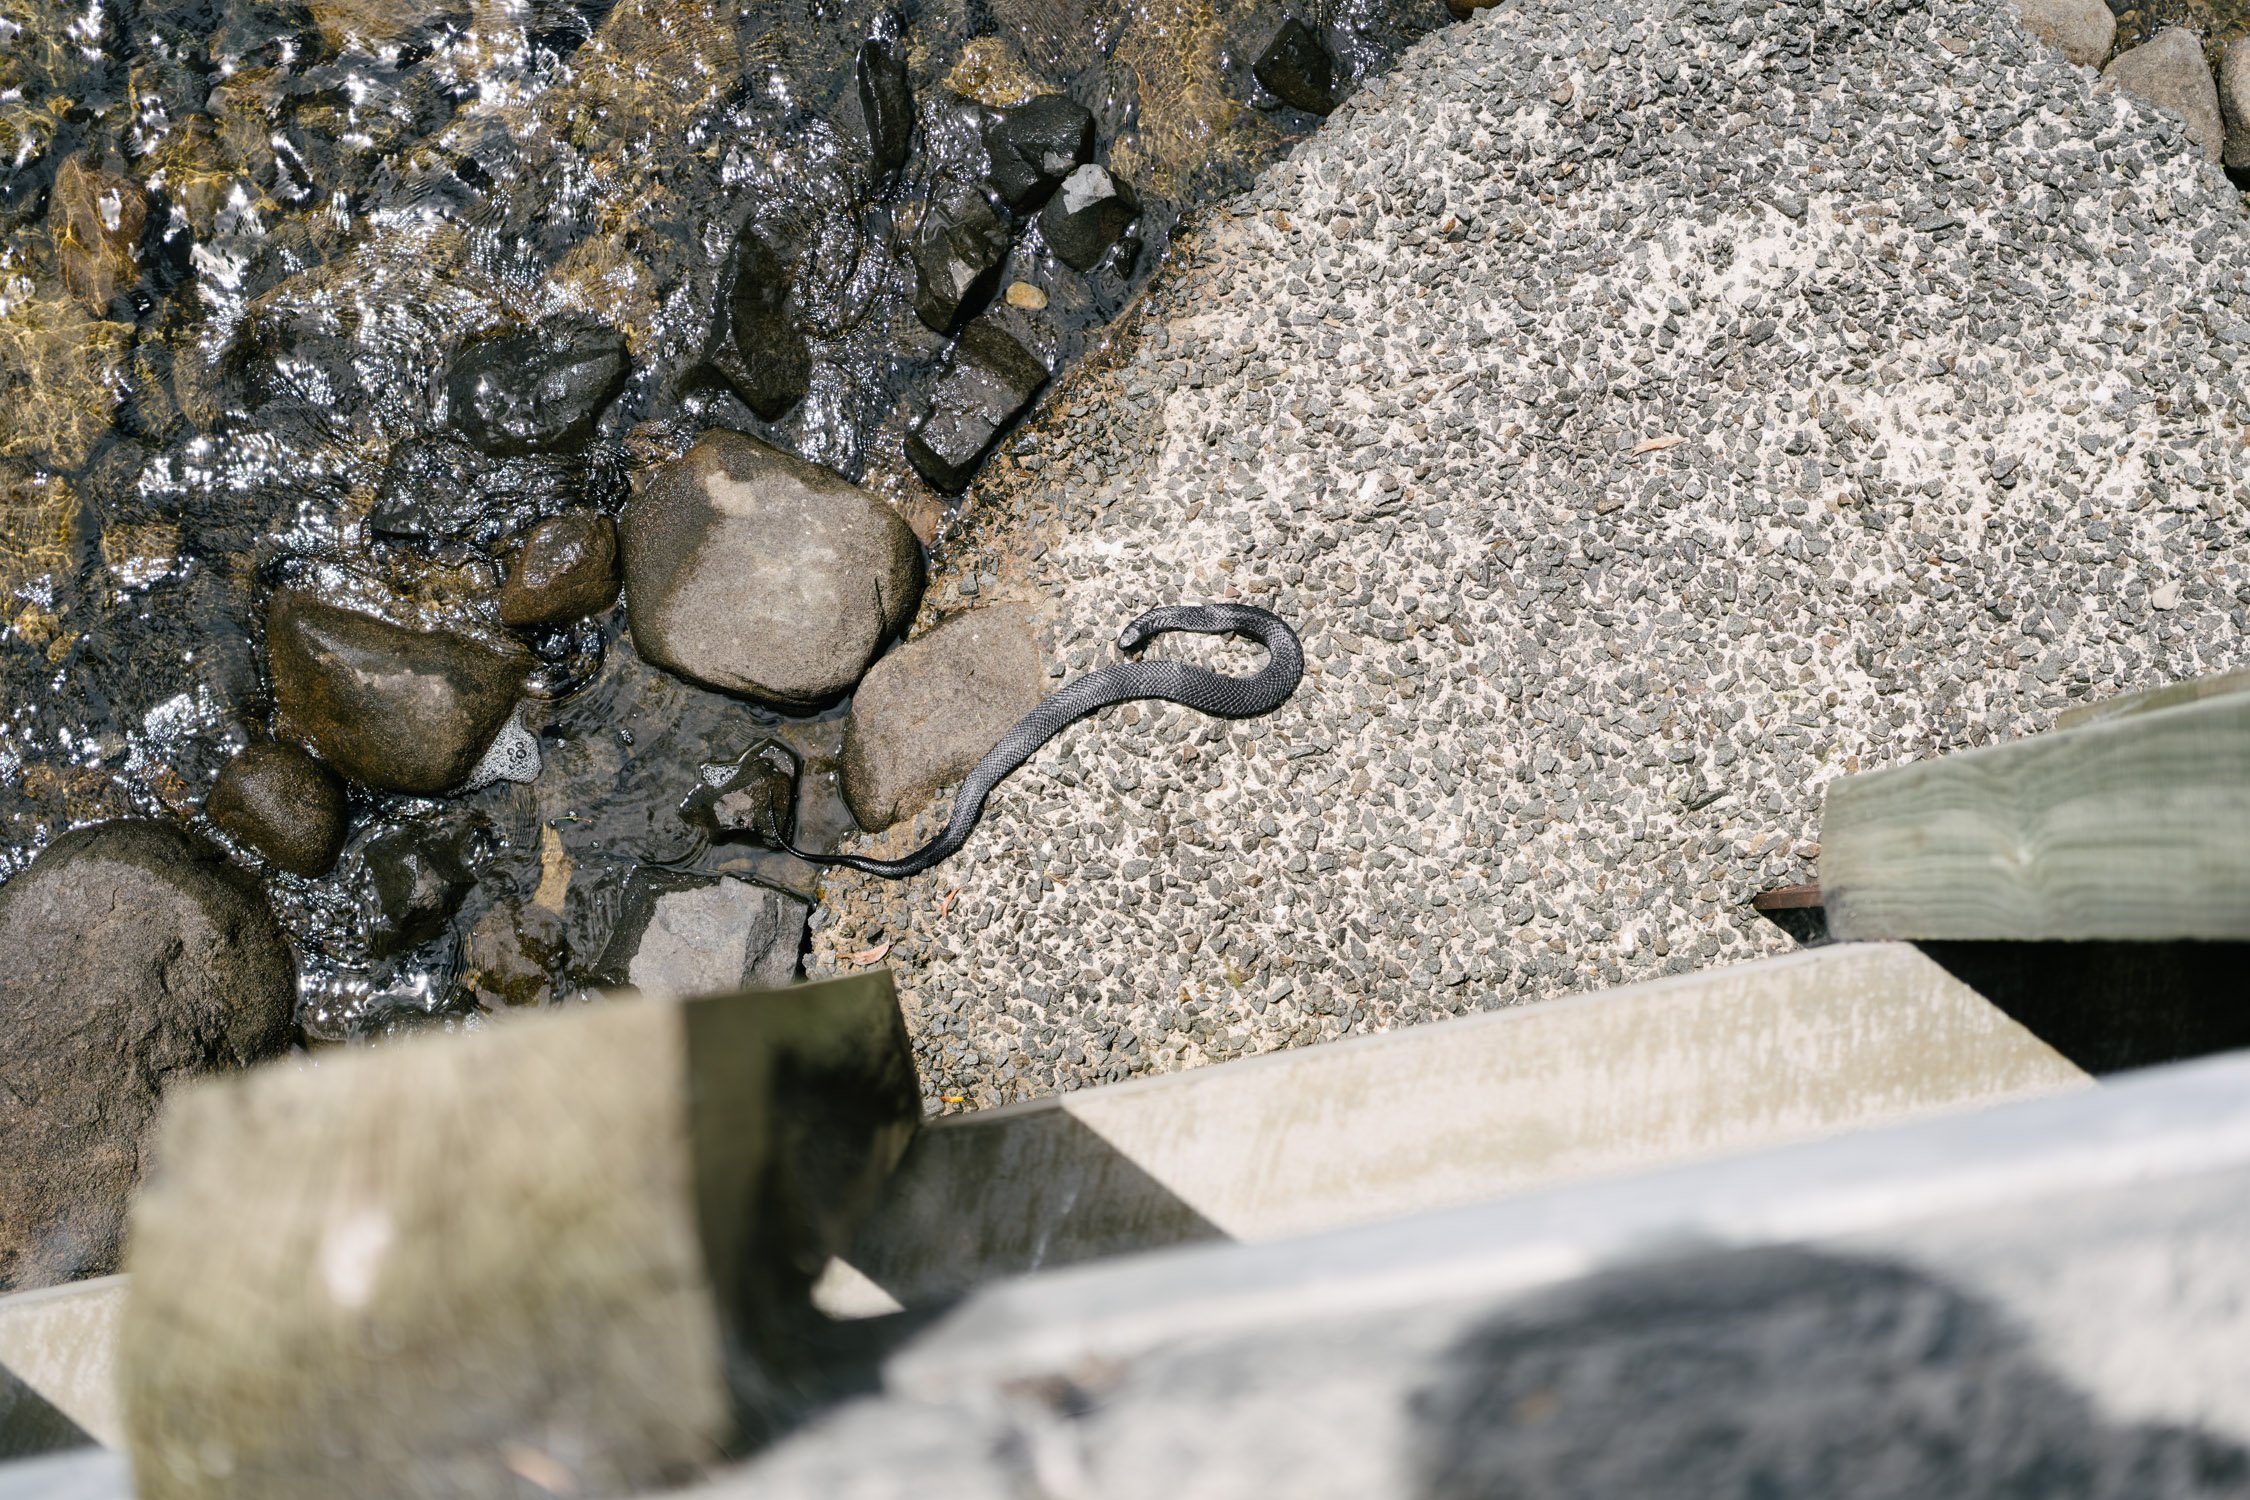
xmin=0 ymin=1275 xmax=126 ymax=1457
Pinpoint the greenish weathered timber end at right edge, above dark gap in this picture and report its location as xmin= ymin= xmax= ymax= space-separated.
xmin=1820 ymin=695 xmax=2250 ymax=940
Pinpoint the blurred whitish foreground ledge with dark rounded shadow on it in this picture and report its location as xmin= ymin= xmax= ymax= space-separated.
xmin=698 ymin=1057 xmax=2250 ymax=1500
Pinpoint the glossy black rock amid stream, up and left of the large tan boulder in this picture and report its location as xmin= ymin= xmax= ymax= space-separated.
xmin=446 ymin=322 xmax=630 ymax=457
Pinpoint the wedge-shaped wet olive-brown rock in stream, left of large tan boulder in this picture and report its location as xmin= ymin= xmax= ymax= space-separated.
xmin=266 ymin=589 xmax=529 ymax=796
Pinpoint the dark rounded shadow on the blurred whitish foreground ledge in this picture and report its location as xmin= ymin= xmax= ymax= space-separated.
xmin=1415 ymin=1250 xmax=2250 ymax=1500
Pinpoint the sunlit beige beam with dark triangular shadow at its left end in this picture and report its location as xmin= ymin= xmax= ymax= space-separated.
xmin=833 ymin=945 xmax=2086 ymax=1311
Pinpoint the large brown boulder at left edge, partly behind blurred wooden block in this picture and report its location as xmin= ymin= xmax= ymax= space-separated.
xmin=0 ymin=819 xmax=297 ymax=1291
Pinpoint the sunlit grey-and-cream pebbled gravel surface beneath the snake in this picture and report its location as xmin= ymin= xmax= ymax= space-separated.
xmin=812 ymin=0 xmax=2250 ymax=1106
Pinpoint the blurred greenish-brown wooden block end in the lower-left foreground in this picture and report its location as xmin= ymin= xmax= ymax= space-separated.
xmin=119 ymin=974 xmax=920 ymax=1500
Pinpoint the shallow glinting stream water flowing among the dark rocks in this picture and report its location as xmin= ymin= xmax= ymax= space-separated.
xmin=0 ymin=0 xmax=1445 ymax=1039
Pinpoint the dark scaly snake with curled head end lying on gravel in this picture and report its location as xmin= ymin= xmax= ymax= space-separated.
xmin=781 ymin=605 xmax=1305 ymax=879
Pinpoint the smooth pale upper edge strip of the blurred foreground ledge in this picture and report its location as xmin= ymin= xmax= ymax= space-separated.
xmin=884 ymin=1055 xmax=2250 ymax=1399
